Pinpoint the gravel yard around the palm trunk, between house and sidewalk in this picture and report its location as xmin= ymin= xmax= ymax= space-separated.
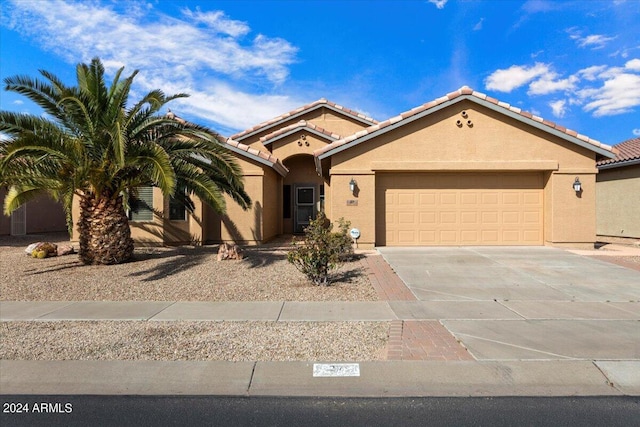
xmin=0 ymin=235 xmax=378 ymax=301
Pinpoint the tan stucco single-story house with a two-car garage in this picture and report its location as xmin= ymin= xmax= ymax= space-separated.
xmin=79 ymin=87 xmax=614 ymax=248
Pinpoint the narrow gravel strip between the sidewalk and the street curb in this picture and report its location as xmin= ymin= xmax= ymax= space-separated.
xmin=0 ymin=321 xmax=389 ymax=362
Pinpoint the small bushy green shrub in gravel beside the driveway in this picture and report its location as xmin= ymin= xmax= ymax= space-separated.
xmin=287 ymin=212 xmax=353 ymax=286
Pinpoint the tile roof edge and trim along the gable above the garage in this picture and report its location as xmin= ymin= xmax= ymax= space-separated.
xmin=314 ymin=86 xmax=613 ymax=158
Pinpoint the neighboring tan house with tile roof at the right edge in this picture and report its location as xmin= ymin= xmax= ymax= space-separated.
xmin=596 ymin=138 xmax=640 ymax=238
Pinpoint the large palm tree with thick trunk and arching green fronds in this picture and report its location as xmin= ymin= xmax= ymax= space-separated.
xmin=0 ymin=58 xmax=251 ymax=264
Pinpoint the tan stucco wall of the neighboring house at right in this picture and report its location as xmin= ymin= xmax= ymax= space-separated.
xmin=596 ymin=165 xmax=640 ymax=238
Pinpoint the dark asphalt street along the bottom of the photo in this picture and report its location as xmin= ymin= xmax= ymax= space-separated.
xmin=0 ymin=395 xmax=640 ymax=427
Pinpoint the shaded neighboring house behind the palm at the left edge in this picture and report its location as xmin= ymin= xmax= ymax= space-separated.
xmin=0 ymin=188 xmax=67 ymax=236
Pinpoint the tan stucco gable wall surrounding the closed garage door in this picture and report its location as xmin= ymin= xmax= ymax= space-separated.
xmin=330 ymin=101 xmax=596 ymax=244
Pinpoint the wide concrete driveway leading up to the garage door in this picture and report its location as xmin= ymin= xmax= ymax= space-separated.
xmin=378 ymin=247 xmax=640 ymax=362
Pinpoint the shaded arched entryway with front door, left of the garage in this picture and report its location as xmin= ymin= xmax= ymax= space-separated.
xmin=282 ymin=154 xmax=324 ymax=234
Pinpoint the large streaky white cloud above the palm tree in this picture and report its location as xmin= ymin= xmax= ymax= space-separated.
xmin=3 ymin=0 xmax=302 ymax=129
